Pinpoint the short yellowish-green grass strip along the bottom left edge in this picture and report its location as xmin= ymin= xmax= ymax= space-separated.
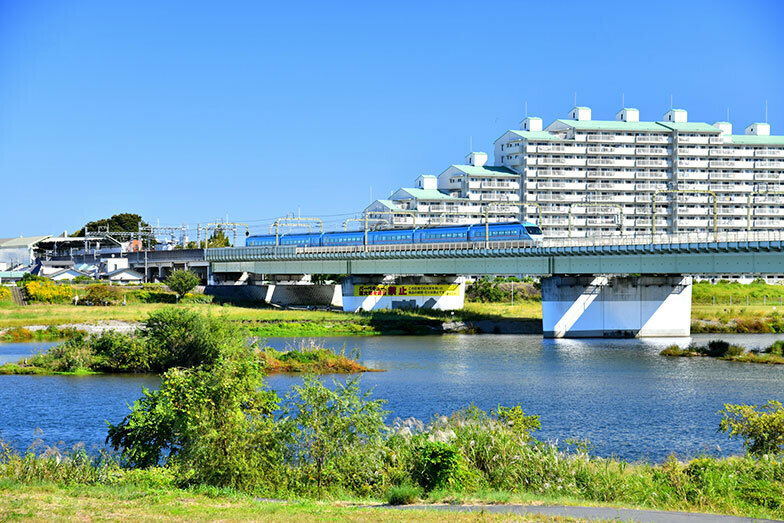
xmin=0 ymin=480 xmax=584 ymax=523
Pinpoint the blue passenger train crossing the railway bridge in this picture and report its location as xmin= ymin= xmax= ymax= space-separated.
xmin=245 ymin=222 xmax=542 ymax=247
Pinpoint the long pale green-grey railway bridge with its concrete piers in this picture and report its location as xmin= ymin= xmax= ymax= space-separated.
xmin=205 ymin=232 xmax=784 ymax=337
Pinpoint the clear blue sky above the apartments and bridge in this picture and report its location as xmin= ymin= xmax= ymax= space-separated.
xmin=0 ymin=0 xmax=784 ymax=237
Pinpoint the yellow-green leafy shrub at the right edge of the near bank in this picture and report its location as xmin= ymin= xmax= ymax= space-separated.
xmin=719 ymin=400 xmax=784 ymax=456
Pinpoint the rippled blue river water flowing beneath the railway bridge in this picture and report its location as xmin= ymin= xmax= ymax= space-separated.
xmin=0 ymin=334 xmax=784 ymax=461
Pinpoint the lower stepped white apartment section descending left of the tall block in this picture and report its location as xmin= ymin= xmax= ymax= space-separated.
xmin=364 ymin=156 xmax=520 ymax=227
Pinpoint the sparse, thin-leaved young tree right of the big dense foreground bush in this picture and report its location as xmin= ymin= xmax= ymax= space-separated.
xmin=284 ymin=376 xmax=387 ymax=497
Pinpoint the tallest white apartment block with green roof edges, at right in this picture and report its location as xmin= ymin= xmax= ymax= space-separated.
xmin=495 ymin=107 xmax=784 ymax=238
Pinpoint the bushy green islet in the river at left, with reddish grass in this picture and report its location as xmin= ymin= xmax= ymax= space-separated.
xmin=0 ymin=307 xmax=371 ymax=374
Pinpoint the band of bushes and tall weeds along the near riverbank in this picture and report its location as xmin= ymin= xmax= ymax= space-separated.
xmin=0 ymin=309 xmax=784 ymax=518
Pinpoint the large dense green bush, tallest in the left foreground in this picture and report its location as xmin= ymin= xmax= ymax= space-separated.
xmin=107 ymin=345 xmax=282 ymax=490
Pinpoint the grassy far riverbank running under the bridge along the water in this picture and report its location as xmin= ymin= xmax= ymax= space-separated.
xmin=0 ymin=286 xmax=784 ymax=341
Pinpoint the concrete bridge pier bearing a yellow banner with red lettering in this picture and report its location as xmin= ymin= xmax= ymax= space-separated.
xmin=341 ymin=274 xmax=465 ymax=312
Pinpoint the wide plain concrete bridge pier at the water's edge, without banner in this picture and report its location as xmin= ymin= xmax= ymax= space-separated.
xmin=542 ymin=275 xmax=692 ymax=338
